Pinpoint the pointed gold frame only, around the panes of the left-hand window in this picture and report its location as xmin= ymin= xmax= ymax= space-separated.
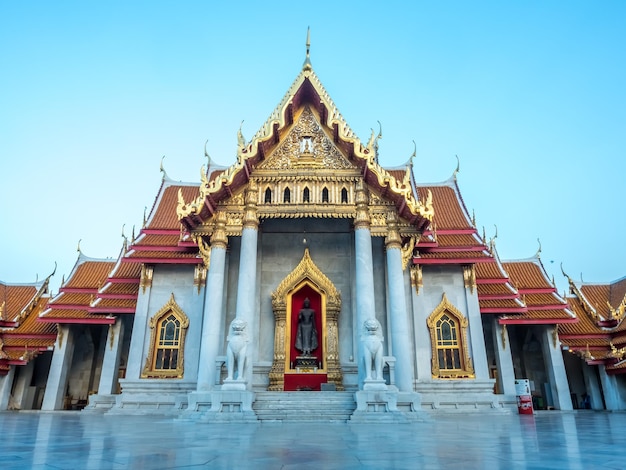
xmin=141 ymin=292 xmax=189 ymax=379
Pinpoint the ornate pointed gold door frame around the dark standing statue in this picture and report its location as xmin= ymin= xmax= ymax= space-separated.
xmin=268 ymin=248 xmax=344 ymax=391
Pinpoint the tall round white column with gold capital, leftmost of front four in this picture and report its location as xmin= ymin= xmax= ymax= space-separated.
xmin=197 ymin=212 xmax=228 ymax=392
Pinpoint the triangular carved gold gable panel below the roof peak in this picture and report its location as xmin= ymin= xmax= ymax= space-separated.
xmin=257 ymin=107 xmax=355 ymax=170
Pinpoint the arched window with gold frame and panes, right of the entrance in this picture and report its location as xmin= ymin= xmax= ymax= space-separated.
xmin=426 ymin=294 xmax=474 ymax=379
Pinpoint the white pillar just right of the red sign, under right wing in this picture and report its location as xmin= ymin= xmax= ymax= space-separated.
xmin=538 ymin=325 xmax=573 ymax=411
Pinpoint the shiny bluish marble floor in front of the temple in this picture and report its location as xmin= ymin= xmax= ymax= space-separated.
xmin=0 ymin=411 xmax=626 ymax=470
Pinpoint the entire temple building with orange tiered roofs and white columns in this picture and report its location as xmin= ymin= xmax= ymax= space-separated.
xmin=0 ymin=45 xmax=626 ymax=421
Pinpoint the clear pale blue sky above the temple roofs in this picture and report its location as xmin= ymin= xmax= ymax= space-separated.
xmin=0 ymin=1 xmax=626 ymax=291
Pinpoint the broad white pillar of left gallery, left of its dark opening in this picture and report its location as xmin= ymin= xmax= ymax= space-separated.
xmin=41 ymin=325 xmax=74 ymax=411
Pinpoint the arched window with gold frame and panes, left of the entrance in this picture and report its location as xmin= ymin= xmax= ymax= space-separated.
xmin=141 ymin=294 xmax=189 ymax=379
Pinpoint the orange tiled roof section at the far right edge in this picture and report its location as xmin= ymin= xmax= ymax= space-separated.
xmin=559 ymin=276 xmax=626 ymax=374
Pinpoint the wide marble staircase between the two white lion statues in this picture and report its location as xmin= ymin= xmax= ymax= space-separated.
xmin=252 ymin=391 xmax=356 ymax=423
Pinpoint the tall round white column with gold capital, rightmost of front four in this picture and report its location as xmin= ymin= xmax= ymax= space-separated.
xmin=385 ymin=212 xmax=414 ymax=392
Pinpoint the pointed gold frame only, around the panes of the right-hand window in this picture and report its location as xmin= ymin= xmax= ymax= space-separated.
xmin=426 ymin=292 xmax=476 ymax=379
